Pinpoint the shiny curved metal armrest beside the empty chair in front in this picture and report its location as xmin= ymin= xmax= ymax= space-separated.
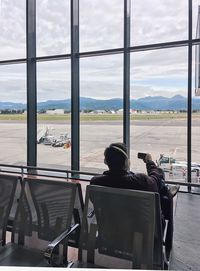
xmin=44 ymin=224 xmax=80 ymax=264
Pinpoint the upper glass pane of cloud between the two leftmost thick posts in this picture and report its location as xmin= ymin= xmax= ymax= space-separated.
xmin=36 ymin=0 xmax=70 ymax=56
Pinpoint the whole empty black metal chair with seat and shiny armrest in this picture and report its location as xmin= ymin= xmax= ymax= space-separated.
xmin=0 ymin=178 xmax=79 ymax=266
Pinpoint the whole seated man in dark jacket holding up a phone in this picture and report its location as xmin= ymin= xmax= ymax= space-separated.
xmin=90 ymin=143 xmax=180 ymax=260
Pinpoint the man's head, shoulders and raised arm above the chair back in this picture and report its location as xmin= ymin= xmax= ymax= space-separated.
xmin=90 ymin=143 xmax=179 ymax=199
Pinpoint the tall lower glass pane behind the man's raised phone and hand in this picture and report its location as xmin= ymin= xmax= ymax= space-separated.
xmin=131 ymin=48 xmax=187 ymax=184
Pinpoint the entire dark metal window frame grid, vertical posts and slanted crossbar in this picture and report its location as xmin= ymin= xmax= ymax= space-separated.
xmin=0 ymin=0 xmax=200 ymax=185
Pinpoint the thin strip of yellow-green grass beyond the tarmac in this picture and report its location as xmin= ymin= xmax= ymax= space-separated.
xmin=0 ymin=112 xmax=197 ymax=122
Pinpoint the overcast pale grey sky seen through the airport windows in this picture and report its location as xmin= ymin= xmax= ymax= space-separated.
xmin=0 ymin=0 xmax=200 ymax=102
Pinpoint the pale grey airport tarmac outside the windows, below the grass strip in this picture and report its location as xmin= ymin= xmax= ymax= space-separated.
xmin=0 ymin=119 xmax=200 ymax=183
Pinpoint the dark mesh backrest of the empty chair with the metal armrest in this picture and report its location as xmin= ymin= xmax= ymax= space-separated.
xmin=12 ymin=178 xmax=77 ymax=253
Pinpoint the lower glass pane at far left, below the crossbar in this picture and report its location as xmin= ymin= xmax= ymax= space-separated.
xmin=0 ymin=64 xmax=27 ymax=165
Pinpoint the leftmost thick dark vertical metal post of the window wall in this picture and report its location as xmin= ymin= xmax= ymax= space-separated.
xmin=26 ymin=0 xmax=37 ymax=166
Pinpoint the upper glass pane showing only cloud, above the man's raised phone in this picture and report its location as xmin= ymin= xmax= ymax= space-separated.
xmin=131 ymin=0 xmax=188 ymax=46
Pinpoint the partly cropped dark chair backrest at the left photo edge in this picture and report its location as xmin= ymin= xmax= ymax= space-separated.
xmin=0 ymin=174 xmax=20 ymax=245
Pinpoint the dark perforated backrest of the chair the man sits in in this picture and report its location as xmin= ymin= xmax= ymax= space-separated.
xmin=79 ymin=185 xmax=162 ymax=269
